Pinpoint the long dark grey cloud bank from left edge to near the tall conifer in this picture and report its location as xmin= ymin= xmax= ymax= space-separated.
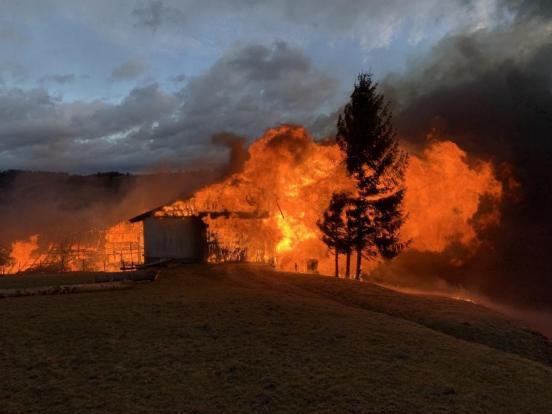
xmin=0 ymin=42 xmax=336 ymax=171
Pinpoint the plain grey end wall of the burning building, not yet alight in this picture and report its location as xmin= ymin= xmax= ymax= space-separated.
xmin=144 ymin=217 xmax=207 ymax=263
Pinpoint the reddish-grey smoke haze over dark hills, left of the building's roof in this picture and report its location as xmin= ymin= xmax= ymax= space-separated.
xmin=0 ymin=166 xmax=222 ymax=250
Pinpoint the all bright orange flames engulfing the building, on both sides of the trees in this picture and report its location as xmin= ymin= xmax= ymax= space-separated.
xmin=3 ymin=125 xmax=502 ymax=273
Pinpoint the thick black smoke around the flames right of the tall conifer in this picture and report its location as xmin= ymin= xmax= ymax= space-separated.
xmin=382 ymin=1 xmax=552 ymax=306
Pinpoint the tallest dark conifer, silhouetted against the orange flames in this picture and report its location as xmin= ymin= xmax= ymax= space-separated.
xmin=336 ymin=73 xmax=407 ymax=279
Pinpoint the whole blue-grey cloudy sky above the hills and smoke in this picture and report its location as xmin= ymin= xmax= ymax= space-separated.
xmin=0 ymin=0 xmax=551 ymax=173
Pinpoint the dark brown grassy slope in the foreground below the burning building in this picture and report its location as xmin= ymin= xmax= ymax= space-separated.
xmin=0 ymin=265 xmax=552 ymax=413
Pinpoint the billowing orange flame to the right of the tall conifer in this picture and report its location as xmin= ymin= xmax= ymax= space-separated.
xmin=403 ymin=141 xmax=502 ymax=252
